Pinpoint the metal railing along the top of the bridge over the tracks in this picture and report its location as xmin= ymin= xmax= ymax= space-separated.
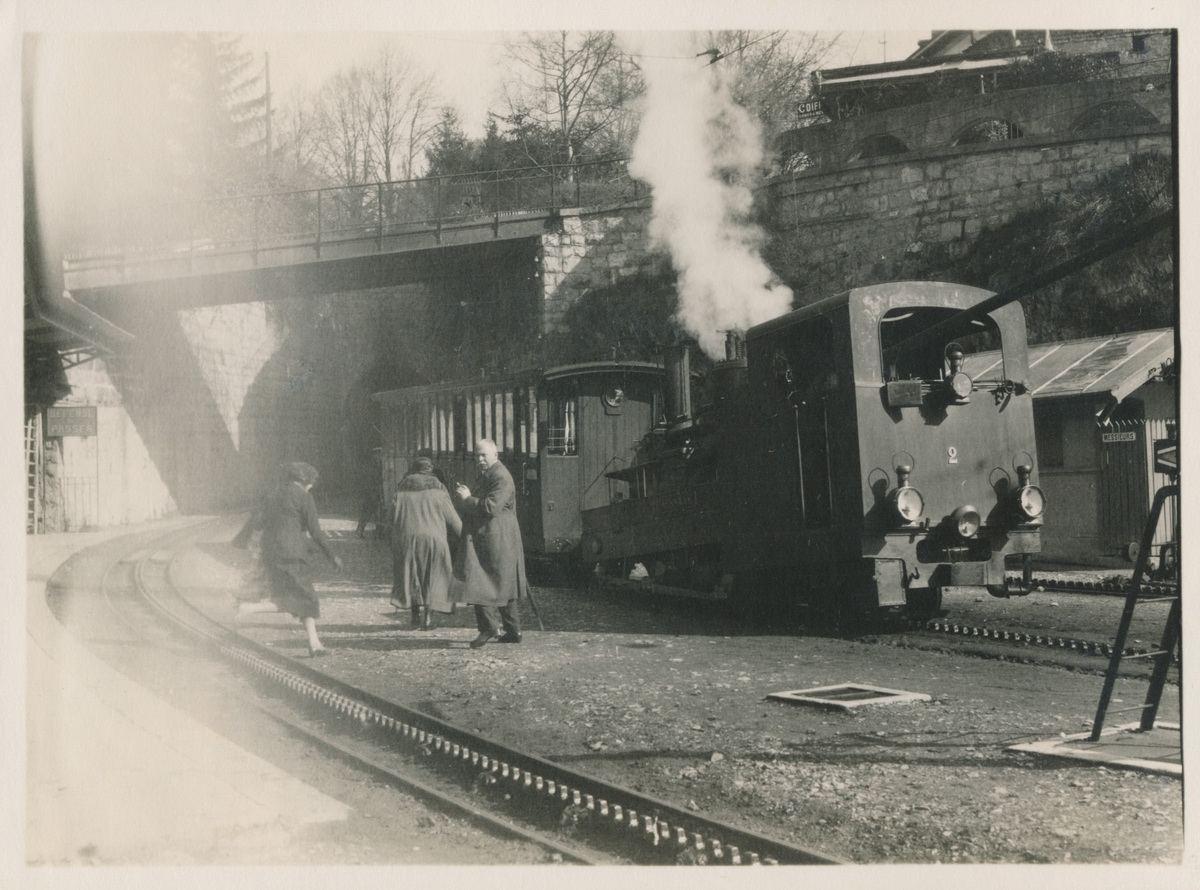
xmin=65 ymin=158 xmax=648 ymax=266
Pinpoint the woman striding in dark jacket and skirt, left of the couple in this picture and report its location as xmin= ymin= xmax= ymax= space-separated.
xmin=238 ymin=463 xmax=342 ymax=657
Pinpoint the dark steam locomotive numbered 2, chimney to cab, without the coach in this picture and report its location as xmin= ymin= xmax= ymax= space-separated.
xmin=581 ymin=282 xmax=1045 ymax=615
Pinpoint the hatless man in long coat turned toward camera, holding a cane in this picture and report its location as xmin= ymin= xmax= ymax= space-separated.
xmin=456 ymin=439 xmax=529 ymax=649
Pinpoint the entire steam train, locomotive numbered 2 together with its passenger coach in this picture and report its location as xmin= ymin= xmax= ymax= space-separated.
xmin=376 ymin=282 xmax=1045 ymax=615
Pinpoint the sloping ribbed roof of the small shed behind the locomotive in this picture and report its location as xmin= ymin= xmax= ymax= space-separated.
xmin=966 ymin=327 xmax=1175 ymax=401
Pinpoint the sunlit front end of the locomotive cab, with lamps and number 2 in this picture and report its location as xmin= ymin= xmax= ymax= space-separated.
xmin=859 ymin=285 xmax=1045 ymax=617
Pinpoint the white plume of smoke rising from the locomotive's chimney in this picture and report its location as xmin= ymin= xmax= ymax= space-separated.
xmin=625 ymin=32 xmax=792 ymax=357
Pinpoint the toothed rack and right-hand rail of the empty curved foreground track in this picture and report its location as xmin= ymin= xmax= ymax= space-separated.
xmin=134 ymin=532 xmax=842 ymax=865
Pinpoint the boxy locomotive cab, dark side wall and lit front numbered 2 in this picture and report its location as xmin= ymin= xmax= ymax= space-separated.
xmin=733 ymin=282 xmax=1045 ymax=615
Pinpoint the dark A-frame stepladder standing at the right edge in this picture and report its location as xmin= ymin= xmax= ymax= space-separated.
xmin=1088 ymin=474 xmax=1182 ymax=741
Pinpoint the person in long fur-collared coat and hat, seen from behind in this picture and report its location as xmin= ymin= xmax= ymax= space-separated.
xmin=391 ymin=457 xmax=462 ymax=630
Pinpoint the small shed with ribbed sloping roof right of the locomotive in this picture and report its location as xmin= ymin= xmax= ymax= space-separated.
xmin=966 ymin=329 xmax=1178 ymax=566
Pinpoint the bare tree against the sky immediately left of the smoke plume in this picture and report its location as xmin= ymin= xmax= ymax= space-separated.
xmin=503 ymin=31 xmax=624 ymax=162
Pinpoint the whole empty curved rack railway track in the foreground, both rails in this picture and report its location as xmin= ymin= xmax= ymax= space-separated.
xmin=105 ymin=528 xmax=840 ymax=865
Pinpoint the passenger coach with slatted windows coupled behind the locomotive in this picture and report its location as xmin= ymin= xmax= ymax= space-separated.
xmin=373 ymin=361 xmax=662 ymax=578
